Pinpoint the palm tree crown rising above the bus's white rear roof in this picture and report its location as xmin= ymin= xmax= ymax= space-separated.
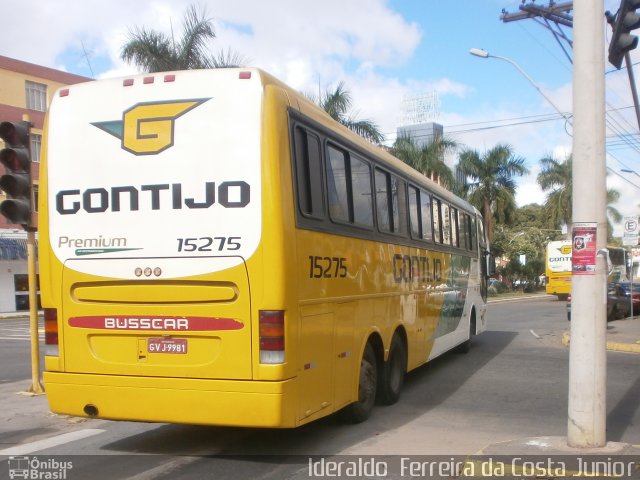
xmin=120 ymin=5 xmax=243 ymax=73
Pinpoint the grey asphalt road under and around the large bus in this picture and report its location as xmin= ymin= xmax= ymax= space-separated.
xmin=0 ymin=298 xmax=640 ymax=479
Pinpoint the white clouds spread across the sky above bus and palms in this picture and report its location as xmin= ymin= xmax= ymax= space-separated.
xmin=0 ymin=0 xmax=640 ymax=237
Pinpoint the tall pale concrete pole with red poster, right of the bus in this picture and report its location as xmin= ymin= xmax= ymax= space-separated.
xmin=567 ymin=0 xmax=607 ymax=448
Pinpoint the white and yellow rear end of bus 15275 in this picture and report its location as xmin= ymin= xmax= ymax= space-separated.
xmin=39 ymin=69 xmax=296 ymax=427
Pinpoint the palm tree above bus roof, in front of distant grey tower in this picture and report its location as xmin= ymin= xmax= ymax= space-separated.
xmin=391 ymin=136 xmax=458 ymax=190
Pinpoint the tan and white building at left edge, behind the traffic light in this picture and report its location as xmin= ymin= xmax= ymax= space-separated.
xmin=0 ymin=56 xmax=91 ymax=312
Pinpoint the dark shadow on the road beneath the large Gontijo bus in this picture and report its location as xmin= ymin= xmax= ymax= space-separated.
xmin=104 ymin=331 xmax=516 ymax=456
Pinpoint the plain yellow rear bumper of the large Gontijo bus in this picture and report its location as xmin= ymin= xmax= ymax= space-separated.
xmin=44 ymin=372 xmax=296 ymax=428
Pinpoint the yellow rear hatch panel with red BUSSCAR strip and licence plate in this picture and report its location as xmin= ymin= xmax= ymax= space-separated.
xmin=59 ymin=257 xmax=252 ymax=379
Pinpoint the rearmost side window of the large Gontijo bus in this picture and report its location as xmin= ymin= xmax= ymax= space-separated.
xmin=294 ymin=126 xmax=324 ymax=219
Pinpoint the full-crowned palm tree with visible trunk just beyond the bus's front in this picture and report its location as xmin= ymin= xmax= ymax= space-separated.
xmin=459 ymin=144 xmax=529 ymax=240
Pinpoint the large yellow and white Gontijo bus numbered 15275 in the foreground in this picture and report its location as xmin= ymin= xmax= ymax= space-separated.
xmin=39 ymin=69 xmax=489 ymax=427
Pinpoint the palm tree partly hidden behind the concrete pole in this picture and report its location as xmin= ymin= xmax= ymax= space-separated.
xmin=537 ymin=155 xmax=622 ymax=237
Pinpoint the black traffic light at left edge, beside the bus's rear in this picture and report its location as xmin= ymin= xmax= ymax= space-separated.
xmin=0 ymin=121 xmax=33 ymax=228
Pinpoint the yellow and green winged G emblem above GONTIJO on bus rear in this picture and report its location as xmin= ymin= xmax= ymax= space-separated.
xmin=91 ymin=98 xmax=209 ymax=155
